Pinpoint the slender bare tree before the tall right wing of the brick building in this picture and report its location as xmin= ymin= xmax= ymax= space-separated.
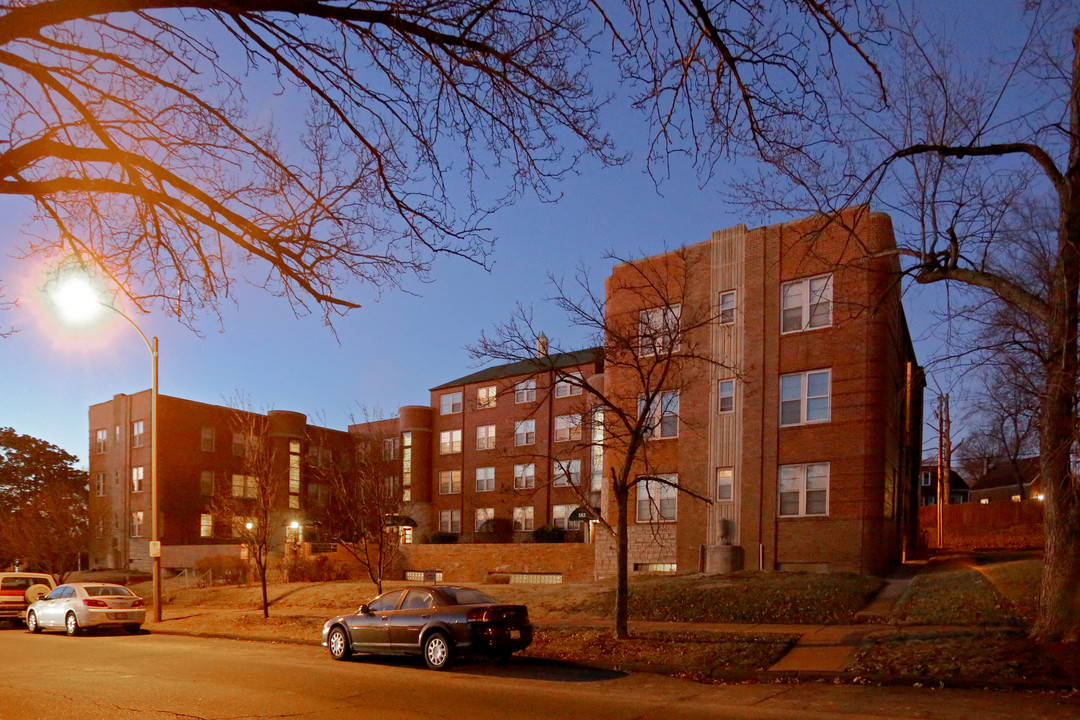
xmin=470 ymin=247 xmax=719 ymax=638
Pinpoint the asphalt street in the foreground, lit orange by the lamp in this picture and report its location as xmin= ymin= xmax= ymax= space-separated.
xmin=0 ymin=629 xmax=1080 ymax=720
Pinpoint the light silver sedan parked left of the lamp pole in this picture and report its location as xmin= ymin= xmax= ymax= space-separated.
xmin=26 ymin=583 xmax=146 ymax=635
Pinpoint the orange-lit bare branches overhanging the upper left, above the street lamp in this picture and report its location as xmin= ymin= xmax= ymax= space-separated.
xmin=0 ymin=0 xmax=618 ymax=322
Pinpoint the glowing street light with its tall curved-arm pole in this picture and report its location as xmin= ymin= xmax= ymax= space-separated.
xmin=51 ymin=274 xmax=161 ymax=623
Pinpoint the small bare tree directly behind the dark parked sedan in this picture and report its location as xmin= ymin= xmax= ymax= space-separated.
xmin=320 ymin=410 xmax=407 ymax=593
